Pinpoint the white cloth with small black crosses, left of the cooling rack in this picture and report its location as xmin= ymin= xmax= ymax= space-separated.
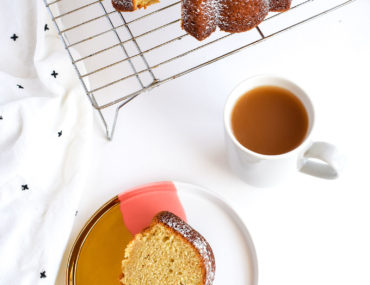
xmin=0 ymin=0 xmax=92 ymax=285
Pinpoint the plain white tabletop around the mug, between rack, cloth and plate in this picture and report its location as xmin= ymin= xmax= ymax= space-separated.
xmin=56 ymin=0 xmax=370 ymax=285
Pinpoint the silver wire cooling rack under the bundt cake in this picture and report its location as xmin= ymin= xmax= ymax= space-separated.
xmin=44 ymin=0 xmax=355 ymax=139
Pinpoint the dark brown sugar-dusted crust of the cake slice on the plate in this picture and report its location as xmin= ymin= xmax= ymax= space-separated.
xmin=157 ymin=212 xmax=216 ymax=285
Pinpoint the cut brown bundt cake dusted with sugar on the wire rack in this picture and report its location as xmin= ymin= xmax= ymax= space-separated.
xmin=112 ymin=0 xmax=292 ymax=41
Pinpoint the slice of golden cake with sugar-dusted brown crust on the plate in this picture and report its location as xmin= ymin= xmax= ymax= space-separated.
xmin=121 ymin=212 xmax=215 ymax=285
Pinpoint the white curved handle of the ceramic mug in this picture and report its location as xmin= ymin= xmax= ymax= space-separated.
xmin=298 ymin=142 xmax=343 ymax=179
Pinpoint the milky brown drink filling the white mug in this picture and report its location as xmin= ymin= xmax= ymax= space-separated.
xmin=231 ymin=86 xmax=308 ymax=155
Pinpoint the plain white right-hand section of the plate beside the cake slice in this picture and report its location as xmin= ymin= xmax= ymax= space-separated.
xmin=174 ymin=182 xmax=258 ymax=285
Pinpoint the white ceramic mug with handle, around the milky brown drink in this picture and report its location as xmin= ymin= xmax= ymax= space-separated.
xmin=224 ymin=75 xmax=342 ymax=187
